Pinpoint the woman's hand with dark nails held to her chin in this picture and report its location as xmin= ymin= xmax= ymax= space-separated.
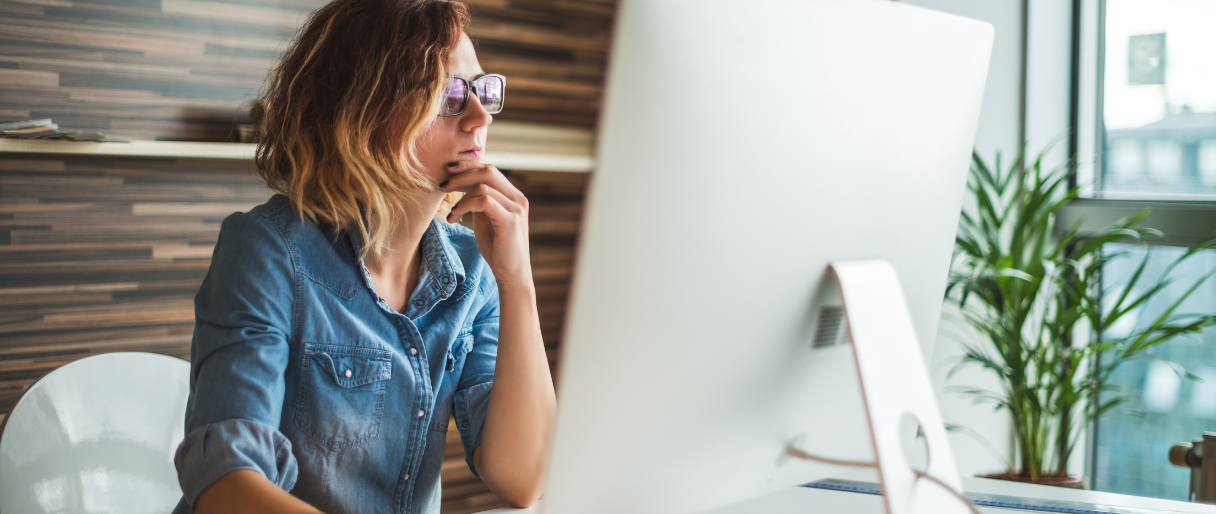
xmin=439 ymin=160 xmax=531 ymax=287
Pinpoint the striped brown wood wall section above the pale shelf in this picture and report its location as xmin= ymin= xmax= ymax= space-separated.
xmin=0 ymin=0 xmax=614 ymax=141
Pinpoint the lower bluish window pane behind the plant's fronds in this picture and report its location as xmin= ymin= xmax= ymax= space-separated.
xmin=1093 ymin=244 xmax=1216 ymax=501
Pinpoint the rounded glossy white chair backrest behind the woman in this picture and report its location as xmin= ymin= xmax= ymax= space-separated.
xmin=0 ymin=352 xmax=190 ymax=514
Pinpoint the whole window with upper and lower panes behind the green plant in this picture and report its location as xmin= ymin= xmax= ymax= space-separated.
xmin=1079 ymin=0 xmax=1216 ymax=499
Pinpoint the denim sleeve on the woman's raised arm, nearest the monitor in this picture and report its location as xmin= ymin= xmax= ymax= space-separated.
xmin=455 ymin=276 xmax=499 ymax=476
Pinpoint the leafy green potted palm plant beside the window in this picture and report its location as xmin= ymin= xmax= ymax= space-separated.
xmin=946 ymin=145 xmax=1216 ymax=487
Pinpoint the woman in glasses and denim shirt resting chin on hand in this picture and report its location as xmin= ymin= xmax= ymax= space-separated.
xmin=175 ymin=0 xmax=556 ymax=513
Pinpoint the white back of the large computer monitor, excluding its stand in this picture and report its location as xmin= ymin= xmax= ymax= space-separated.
xmin=541 ymin=0 xmax=992 ymax=514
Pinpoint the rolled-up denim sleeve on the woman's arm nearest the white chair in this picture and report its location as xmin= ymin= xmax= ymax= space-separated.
xmin=174 ymin=214 xmax=297 ymax=505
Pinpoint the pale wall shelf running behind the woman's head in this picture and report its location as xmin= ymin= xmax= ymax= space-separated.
xmin=0 ymin=122 xmax=595 ymax=173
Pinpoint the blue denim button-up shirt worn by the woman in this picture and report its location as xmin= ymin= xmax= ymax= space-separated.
xmin=174 ymin=196 xmax=499 ymax=514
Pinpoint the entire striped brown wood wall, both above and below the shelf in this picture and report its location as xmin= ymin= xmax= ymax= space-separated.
xmin=0 ymin=0 xmax=615 ymax=513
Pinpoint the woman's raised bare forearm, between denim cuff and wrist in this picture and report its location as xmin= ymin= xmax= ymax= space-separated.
xmin=473 ymin=277 xmax=557 ymax=507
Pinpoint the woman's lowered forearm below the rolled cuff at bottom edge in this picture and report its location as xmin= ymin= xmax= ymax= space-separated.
xmin=195 ymin=469 xmax=321 ymax=514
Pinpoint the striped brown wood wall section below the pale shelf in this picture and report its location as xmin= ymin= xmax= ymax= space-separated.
xmin=0 ymin=156 xmax=589 ymax=514
